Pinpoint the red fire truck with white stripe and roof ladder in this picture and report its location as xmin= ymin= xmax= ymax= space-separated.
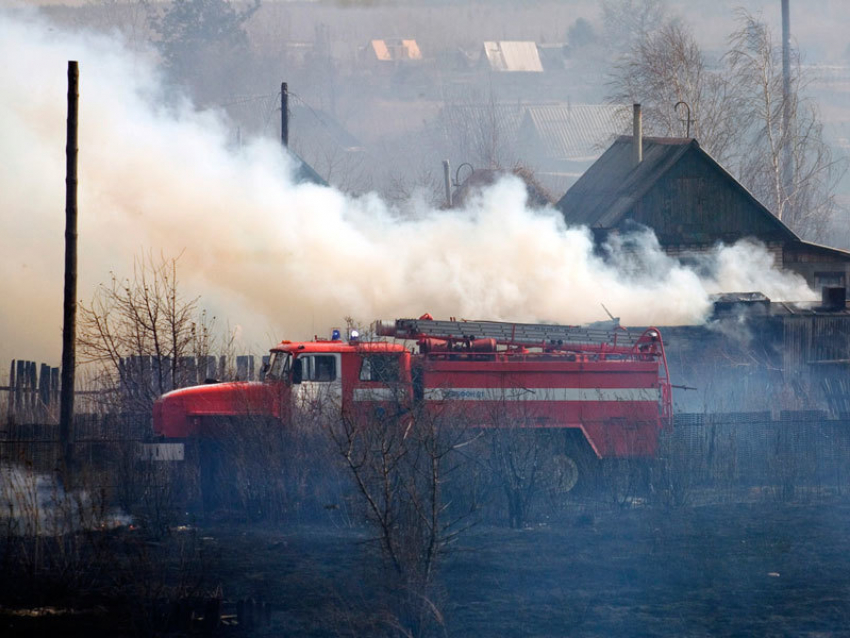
xmin=150 ymin=315 xmax=672 ymax=487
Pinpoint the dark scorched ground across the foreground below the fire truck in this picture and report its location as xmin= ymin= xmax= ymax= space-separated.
xmin=0 ymin=500 xmax=850 ymax=637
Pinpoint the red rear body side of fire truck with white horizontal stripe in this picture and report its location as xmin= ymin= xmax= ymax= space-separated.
xmin=424 ymin=360 xmax=662 ymax=458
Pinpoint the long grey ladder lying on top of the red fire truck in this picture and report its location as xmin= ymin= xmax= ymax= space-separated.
xmin=376 ymin=319 xmax=643 ymax=348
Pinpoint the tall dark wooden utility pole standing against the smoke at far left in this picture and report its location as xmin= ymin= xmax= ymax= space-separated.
xmin=59 ymin=61 xmax=80 ymax=487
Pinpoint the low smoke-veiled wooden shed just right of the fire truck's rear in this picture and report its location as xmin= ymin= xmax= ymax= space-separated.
xmin=659 ymin=302 xmax=850 ymax=424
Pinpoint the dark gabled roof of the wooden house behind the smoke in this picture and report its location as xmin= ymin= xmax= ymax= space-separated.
xmin=557 ymin=135 xmax=799 ymax=241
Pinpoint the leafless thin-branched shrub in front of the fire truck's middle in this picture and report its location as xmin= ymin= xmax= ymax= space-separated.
xmin=327 ymin=395 xmax=474 ymax=636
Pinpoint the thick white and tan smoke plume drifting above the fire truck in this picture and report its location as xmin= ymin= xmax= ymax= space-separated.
xmin=0 ymin=13 xmax=812 ymax=362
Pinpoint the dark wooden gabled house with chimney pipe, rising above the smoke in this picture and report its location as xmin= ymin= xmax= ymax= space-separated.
xmin=557 ymin=136 xmax=850 ymax=290
